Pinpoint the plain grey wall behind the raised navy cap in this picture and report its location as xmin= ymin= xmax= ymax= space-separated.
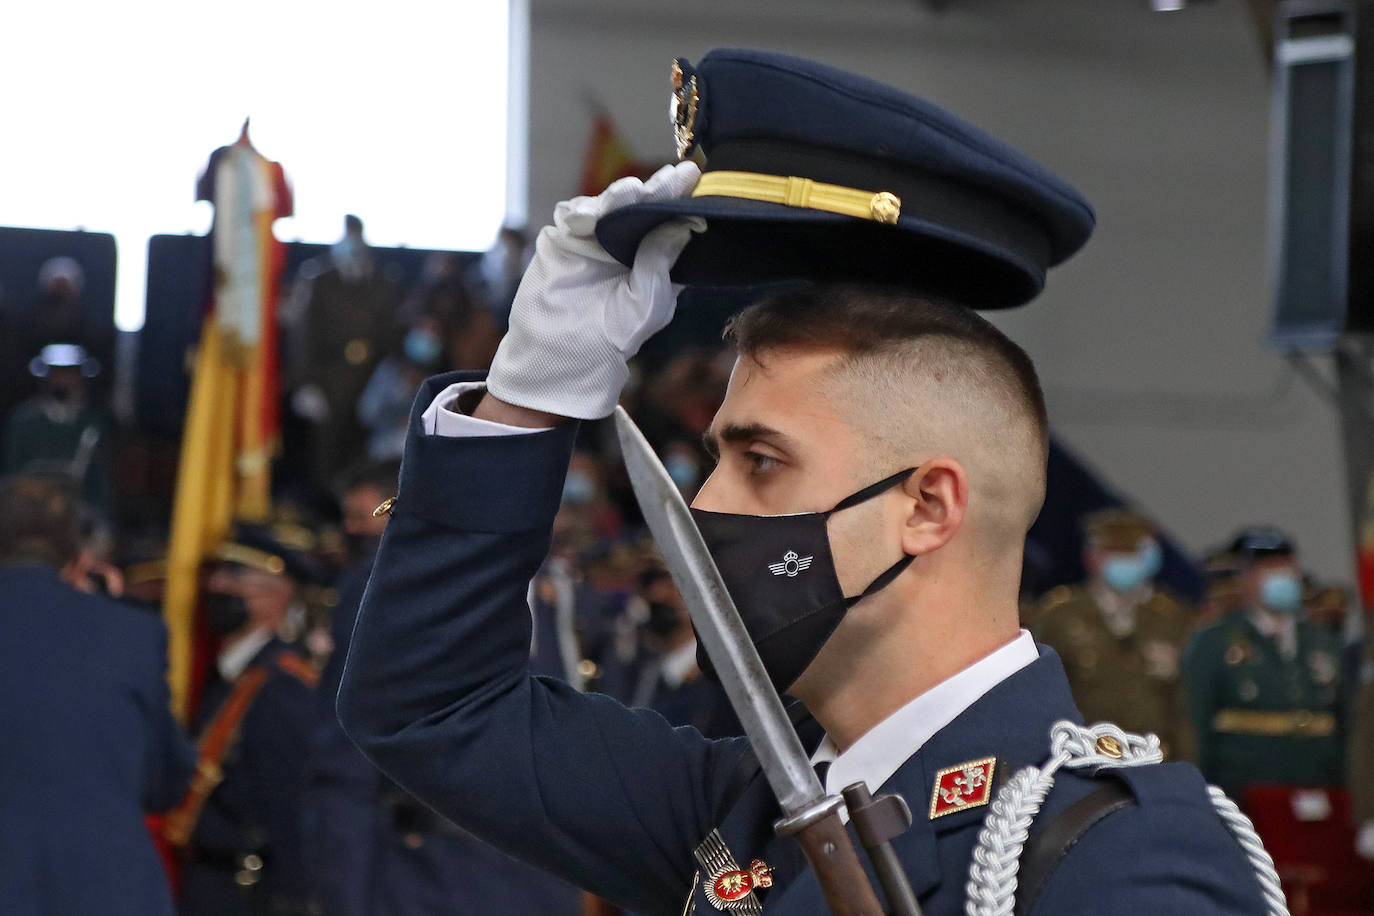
xmin=529 ymin=0 xmax=1352 ymax=581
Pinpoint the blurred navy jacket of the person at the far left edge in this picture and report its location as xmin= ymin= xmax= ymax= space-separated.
xmin=0 ymin=566 xmax=195 ymax=916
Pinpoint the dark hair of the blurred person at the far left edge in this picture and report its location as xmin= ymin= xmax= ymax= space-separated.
xmin=0 ymin=474 xmax=81 ymax=569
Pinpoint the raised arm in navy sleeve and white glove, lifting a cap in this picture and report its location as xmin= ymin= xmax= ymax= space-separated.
xmin=338 ymin=166 xmax=745 ymax=913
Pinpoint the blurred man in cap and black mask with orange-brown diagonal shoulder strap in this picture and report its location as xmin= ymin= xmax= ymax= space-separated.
xmin=165 ymin=526 xmax=319 ymax=916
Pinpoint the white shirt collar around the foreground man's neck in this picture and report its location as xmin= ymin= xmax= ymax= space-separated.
xmin=811 ymin=630 xmax=1040 ymax=795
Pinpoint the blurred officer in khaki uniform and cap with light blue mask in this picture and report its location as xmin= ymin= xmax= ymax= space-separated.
xmin=1032 ymin=508 xmax=1193 ymax=758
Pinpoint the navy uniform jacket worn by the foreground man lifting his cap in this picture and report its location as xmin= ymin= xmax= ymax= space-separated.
xmin=338 ymin=375 xmax=1264 ymax=916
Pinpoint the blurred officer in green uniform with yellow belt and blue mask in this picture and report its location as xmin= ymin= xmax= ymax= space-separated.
xmin=1183 ymin=529 xmax=1344 ymax=797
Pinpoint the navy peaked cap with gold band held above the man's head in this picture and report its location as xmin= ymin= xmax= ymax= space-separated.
xmin=596 ymin=49 xmax=1095 ymax=308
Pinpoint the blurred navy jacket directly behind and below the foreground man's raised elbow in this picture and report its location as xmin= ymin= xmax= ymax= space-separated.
xmin=305 ymin=549 xmax=581 ymax=916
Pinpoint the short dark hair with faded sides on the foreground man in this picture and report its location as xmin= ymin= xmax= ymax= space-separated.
xmin=724 ymin=284 xmax=1050 ymax=534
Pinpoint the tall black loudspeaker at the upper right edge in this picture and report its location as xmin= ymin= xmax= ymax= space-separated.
xmin=1271 ymin=0 xmax=1374 ymax=349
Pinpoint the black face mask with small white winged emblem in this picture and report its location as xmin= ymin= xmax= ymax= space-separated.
xmin=691 ymin=468 xmax=916 ymax=694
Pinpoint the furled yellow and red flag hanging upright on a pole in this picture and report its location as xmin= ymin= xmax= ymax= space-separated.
xmin=162 ymin=122 xmax=291 ymax=720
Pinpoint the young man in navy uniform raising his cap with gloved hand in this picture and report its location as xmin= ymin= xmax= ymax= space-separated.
xmin=338 ymin=51 xmax=1265 ymax=916
